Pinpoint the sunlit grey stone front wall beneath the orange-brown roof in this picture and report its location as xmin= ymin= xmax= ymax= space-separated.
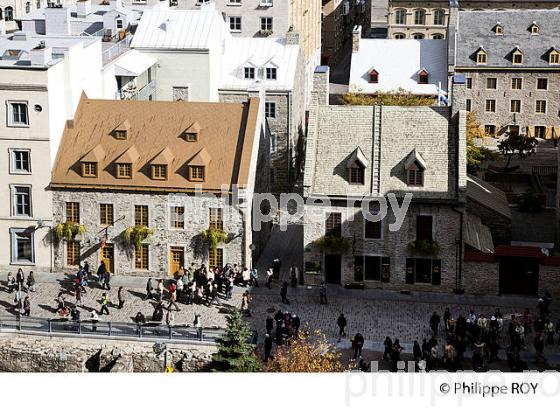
xmin=53 ymin=190 xmax=247 ymax=276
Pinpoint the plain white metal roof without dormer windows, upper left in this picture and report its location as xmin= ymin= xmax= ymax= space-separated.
xmin=132 ymin=10 xmax=229 ymax=50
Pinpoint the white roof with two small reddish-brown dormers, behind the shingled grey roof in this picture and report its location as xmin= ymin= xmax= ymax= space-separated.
xmin=350 ymin=39 xmax=447 ymax=95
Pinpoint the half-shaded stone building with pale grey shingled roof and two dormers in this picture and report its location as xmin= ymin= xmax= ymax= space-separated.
xmin=303 ymin=77 xmax=466 ymax=291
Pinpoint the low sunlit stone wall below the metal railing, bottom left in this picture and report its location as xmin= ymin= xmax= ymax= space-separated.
xmin=0 ymin=333 xmax=216 ymax=373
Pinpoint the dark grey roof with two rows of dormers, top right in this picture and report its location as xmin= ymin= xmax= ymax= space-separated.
xmin=455 ymin=10 xmax=560 ymax=68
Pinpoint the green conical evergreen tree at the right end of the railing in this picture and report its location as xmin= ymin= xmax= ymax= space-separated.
xmin=211 ymin=309 xmax=261 ymax=372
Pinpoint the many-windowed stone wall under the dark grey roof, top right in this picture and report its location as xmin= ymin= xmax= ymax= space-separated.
xmin=452 ymin=67 xmax=560 ymax=138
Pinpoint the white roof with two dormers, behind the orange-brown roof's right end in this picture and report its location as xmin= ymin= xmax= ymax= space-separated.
xmin=219 ymin=37 xmax=299 ymax=90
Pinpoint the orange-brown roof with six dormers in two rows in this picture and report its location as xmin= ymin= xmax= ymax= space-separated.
xmin=51 ymin=97 xmax=259 ymax=192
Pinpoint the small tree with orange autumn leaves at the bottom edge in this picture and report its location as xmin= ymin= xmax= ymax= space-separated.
xmin=266 ymin=330 xmax=347 ymax=373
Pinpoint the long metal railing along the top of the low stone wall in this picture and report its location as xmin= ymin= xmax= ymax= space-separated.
xmin=0 ymin=316 xmax=224 ymax=344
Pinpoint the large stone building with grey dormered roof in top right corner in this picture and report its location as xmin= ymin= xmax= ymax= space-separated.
xmin=448 ymin=8 xmax=560 ymax=139
